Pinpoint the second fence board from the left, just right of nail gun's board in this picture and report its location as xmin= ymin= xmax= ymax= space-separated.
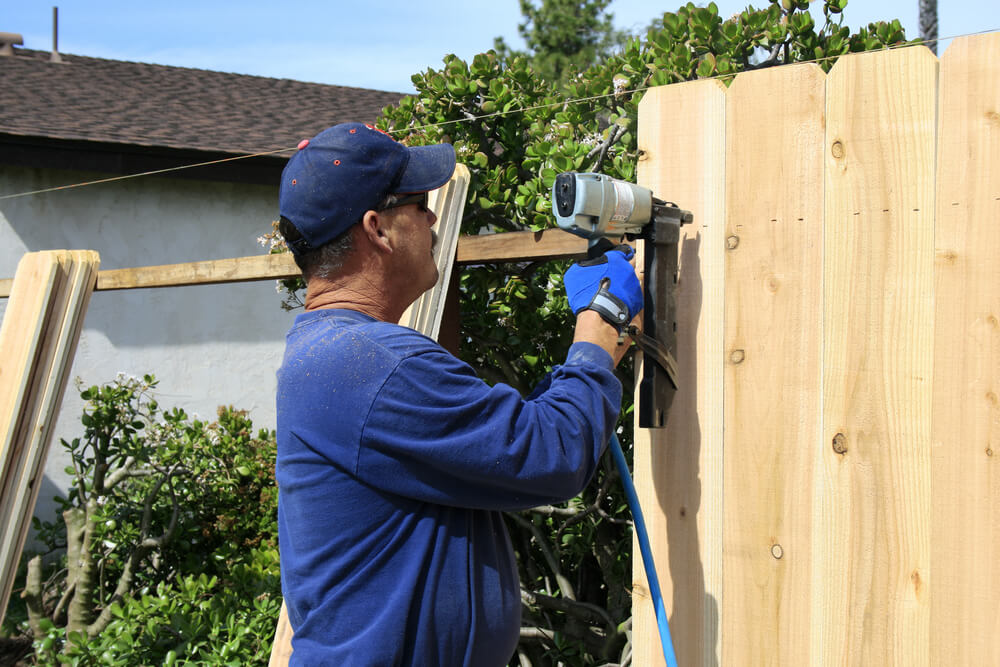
xmin=722 ymin=65 xmax=826 ymax=665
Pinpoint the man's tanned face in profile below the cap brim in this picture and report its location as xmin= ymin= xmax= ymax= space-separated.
xmin=383 ymin=193 xmax=438 ymax=300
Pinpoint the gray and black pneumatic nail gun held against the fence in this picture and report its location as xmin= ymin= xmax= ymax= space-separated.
xmin=552 ymin=172 xmax=693 ymax=428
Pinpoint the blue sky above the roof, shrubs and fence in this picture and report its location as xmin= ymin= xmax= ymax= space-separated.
xmin=0 ymin=0 xmax=1000 ymax=92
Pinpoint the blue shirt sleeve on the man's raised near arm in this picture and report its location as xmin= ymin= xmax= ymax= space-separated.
xmin=356 ymin=343 xmax=622 ymax=510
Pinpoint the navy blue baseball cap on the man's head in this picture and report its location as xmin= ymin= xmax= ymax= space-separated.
xmin=278 ymin=123 xmax=455 ymax=254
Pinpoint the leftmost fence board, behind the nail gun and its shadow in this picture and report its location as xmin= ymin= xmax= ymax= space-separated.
xmin=632 ymin=80 xmax=725 ymax=665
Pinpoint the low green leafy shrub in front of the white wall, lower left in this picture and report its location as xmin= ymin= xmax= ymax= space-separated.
xmin=11 ymin=375 xmax=281 ymax=665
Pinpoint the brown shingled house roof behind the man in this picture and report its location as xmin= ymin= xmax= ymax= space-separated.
xmin=0 ymin=48 xmax=404 ymax=156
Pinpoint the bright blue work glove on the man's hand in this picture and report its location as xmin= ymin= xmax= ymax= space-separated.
xmin=563 ymin=244 xmax=642 ymax=332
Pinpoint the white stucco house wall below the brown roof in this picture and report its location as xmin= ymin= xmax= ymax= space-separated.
xmin=0 ymin=166 xmax=295 ymax=528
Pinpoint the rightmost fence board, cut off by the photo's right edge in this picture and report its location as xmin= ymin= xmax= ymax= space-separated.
xmin=930 ymin=33 xmax=1000 ymax=667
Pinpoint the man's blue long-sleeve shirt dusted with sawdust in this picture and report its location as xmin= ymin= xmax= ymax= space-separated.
xmin=276 ymin=310 xmax=621 ymax=667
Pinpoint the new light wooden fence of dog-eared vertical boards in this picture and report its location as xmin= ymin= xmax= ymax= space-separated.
xmin=634 ymin=33 xmax=1000 ymax=666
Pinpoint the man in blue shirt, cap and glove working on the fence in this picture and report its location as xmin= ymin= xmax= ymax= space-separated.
xmin=276 ymin=123 xmax=642 ymax=667
